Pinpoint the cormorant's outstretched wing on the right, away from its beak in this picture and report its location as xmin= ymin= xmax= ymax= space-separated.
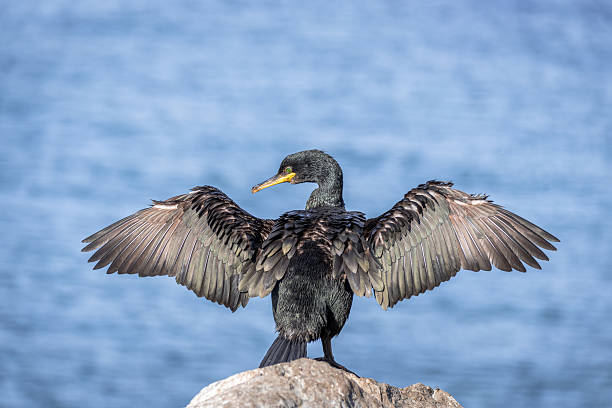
xmin=364 ymin=181 xmax=559 ymax=309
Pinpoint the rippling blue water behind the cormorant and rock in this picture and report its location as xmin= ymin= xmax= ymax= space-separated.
xmin=0 ymin=0 xmax=612 ymax=407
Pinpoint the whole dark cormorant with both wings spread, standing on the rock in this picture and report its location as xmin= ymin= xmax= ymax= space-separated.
xmin=83 ymin=150 xmax=559 ymax=368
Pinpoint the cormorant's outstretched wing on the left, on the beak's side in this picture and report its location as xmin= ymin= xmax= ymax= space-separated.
xmin=82 ymin=186 xmax=274 ymax=311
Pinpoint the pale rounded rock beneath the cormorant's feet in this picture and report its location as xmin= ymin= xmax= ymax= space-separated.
xmin=187 ymin=358 xmax=461 ymax=408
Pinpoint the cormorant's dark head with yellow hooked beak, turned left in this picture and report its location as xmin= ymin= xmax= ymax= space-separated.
xmin=251 ymin=150 xmax=342 ymax=193
